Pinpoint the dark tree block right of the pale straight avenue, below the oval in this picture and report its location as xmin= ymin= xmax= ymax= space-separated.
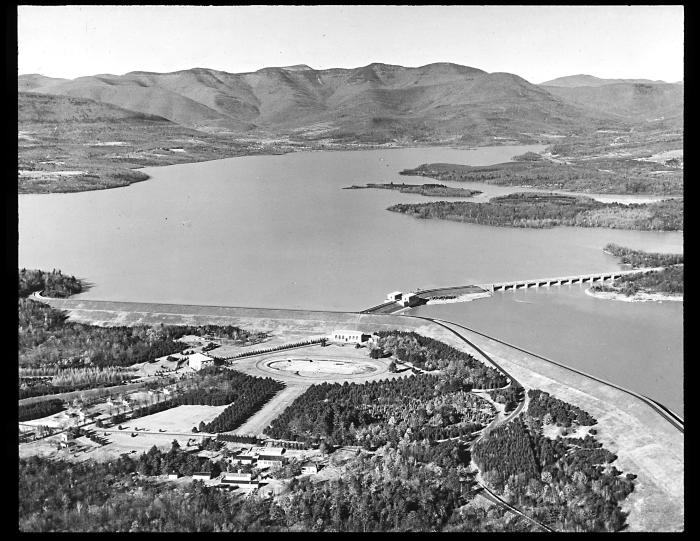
xmin=265 ymin=374 xmax=495 ymax=449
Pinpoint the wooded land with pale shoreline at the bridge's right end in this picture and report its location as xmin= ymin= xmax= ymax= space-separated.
xmin=586 ymin=244 xmax=683 ymax=302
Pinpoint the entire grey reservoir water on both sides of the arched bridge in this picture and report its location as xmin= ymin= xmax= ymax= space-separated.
xmin=19 ymin=145 xmax=683 ymax=411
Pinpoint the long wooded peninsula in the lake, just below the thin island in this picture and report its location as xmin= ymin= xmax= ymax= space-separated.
xmin=387 ymin=192 xmax=683 ymax=231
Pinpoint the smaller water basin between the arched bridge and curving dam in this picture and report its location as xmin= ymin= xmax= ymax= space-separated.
xmin=411 ymin=284 xmax=683 ymax=416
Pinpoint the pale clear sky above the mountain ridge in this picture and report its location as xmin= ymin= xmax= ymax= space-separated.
xmin=17 ymin=5 xmax=684 ymax=83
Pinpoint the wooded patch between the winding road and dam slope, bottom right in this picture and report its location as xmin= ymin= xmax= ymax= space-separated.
xmin=472 ymin=390 xmax=635 ymax=531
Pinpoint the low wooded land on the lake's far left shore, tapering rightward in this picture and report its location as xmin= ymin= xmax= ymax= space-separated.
xmin=17 ymin=92 xmax=266 ymax=193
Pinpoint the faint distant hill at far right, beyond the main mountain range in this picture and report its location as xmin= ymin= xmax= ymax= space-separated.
xmin=542 ymin=83 xmax=684 ymax=125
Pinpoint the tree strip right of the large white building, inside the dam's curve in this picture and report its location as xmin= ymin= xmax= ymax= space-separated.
xmin=370 ymin=331 xmax=508 ymax=390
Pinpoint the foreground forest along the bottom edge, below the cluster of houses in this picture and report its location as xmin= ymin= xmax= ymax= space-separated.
xmin=19 ymin=441 xmax=531 ymax=532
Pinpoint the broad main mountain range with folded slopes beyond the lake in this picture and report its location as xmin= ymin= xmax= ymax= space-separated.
xmin=18 ymin=63 xmax=610 ymax=144
